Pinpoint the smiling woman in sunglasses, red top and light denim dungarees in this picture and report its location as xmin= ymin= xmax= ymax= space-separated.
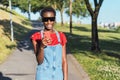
xmin=31 ymin=7 xmax=68 ymax=80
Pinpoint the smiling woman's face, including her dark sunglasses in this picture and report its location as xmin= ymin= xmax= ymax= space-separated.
xmin=42 ymin=12 xmax=55 ymax=30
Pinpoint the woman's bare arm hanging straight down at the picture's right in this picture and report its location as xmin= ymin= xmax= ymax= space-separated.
xmin=62 ymin=44 xmax=68 ymax=80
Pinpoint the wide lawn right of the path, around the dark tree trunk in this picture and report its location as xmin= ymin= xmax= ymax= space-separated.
xmin=56 ymin=22 xmax=120 ymax=80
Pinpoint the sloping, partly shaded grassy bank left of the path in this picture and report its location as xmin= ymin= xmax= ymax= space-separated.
xmin=0 ymin=8 xmax=32 ymax=63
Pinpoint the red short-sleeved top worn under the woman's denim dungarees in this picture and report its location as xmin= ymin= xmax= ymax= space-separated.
xmin=31 ymin=32 xmax=67 ymax=46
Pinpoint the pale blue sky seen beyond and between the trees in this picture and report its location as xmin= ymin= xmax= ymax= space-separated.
xmin=16 ymin=0 xmax=120 ymax=24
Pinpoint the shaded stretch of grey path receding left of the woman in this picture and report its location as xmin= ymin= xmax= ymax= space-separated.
xmin=17 ymin=21 xmax=43 ymax=52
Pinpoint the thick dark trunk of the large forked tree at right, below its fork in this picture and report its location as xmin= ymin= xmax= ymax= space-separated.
xmin=91 ymin=16 xmax=100 ymax=52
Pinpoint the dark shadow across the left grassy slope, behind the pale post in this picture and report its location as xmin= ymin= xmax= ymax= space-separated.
xmin=0 ymin=20 xmax=30 ymax=40
